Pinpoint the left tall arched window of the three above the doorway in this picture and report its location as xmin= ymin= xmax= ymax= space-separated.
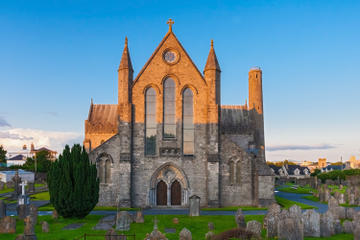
xmin=145 ymin=88 xmax=156 ymax=155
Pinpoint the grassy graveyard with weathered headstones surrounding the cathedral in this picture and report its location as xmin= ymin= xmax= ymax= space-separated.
xmin=0 ymin=170 xmax=360 ymax=240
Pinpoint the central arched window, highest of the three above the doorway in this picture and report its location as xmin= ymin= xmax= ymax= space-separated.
xmin=163 ymin=78 xmax=176 ymax=138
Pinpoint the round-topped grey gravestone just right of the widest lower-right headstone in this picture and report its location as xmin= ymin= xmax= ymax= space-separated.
xmin=302 ymin=209 xmax=320 ymax=237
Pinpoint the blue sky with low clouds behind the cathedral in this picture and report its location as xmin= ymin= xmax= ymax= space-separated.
xmin=0 ymin=0 xmax=360 ymax=161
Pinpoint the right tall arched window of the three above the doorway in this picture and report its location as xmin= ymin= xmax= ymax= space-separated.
xmin=183 ymin=88 xmax=195 ymax=155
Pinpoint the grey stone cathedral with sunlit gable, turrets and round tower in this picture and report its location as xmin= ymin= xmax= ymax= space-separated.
xmin=84 ymin=19 xmax=274 ymax=208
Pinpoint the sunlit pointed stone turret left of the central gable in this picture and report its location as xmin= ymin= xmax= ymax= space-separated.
xmin=118 ymin=37 xmax=134 ymax=104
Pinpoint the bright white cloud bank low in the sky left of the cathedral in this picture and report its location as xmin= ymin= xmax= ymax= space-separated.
xmin=0 ymin=128 xmax=83 ymax=153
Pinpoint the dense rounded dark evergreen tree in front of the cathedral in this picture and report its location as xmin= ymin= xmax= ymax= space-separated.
xmin=48 ymin=144 xmax=99 ymax=218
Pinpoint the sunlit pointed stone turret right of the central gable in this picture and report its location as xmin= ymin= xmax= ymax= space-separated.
xmin=204 ymin=40 xmax=221 ymax=105
